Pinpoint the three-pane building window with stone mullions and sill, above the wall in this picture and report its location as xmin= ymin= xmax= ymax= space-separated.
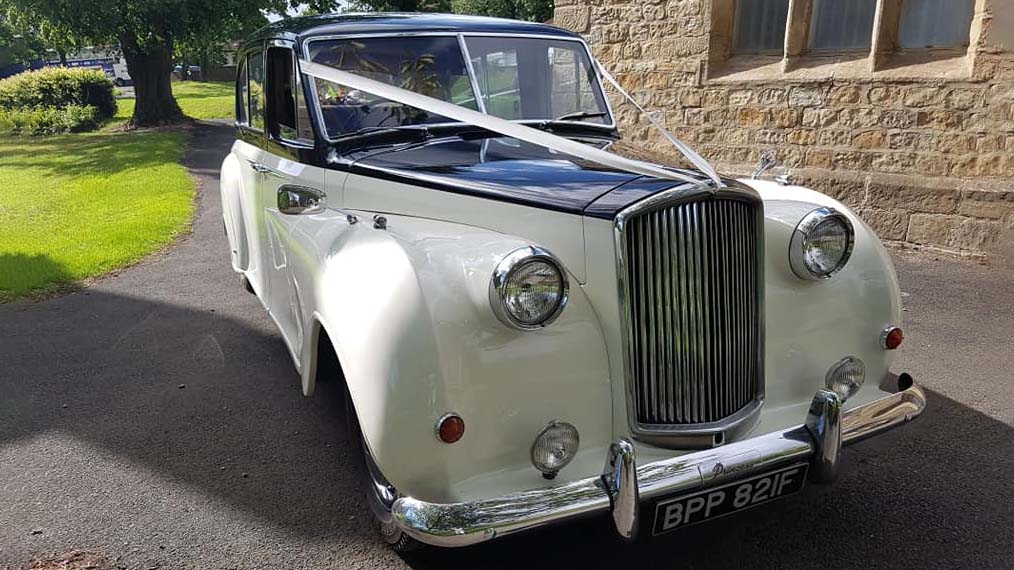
xmin=709 ymin=0 xmax=976 ymax=73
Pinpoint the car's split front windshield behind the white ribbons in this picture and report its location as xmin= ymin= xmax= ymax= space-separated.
xmin=309 ymin=35 xmax=611 ymax=138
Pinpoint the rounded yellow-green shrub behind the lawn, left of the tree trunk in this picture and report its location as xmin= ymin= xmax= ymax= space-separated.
xmin=0 ymin=67 xmax=117 ymax=121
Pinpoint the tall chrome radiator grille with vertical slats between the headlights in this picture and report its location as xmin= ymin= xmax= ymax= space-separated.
xmin=613 ymin=186 xmax=765 ymax=449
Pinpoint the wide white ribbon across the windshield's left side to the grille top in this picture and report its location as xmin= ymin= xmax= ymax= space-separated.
xmin=299 ymin=60 xmax=717 ymax=185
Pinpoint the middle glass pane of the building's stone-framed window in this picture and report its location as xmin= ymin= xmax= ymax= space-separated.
xmin=810 ymin=0 xmax=877 ymax=51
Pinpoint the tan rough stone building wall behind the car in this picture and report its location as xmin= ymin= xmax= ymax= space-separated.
xmin=556 ymin=0 xmax=1014 ymax=256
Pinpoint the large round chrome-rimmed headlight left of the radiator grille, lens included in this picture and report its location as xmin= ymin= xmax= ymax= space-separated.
xmin=490 ymin=246 xmax=569 ymax=331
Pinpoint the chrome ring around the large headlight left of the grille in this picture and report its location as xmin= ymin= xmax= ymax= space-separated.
xmin=490 ymin=245 xmax=570 ymax=331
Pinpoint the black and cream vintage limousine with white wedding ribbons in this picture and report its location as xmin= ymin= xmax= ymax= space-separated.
xmin=221 ymin=14 xmax=926 ymax=549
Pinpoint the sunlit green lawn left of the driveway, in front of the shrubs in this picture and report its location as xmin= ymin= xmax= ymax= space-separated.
xmin=0 ymin=127 xmax=195 ymax=301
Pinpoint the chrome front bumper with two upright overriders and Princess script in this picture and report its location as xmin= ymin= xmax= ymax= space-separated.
xmin=391 ymin=376 xmax=926 ymax=547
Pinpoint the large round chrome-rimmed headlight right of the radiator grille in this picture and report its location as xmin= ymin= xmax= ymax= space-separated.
xmin=789 ymin=208 xmax=856 ymax=280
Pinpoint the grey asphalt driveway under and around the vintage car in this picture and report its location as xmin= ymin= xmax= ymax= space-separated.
xmin=0 ymin=126 xmax=1014 ymax=570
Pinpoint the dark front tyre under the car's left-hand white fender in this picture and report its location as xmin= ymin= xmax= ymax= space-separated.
xmin=345 ymin=387 xmax=417 ymax=553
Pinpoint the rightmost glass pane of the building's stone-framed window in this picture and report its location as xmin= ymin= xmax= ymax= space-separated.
xmin=899 ymin=0 xmax=974 ymax=48
